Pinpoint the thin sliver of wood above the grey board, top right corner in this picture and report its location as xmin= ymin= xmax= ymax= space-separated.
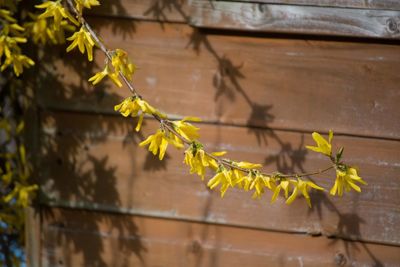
xmin=233 ymin=0 xmax=400 ymax=10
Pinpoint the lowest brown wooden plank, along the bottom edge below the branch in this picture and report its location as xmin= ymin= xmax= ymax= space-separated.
xmin=42 ymin=209 xmax=400 ymax=267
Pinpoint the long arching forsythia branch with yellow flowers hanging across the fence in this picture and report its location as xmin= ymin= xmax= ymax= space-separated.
xmin=60 ymin=0 xmax=366 ymax=207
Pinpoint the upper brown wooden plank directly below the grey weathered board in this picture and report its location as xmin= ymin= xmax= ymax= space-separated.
xmin=38 ymin=19 xmax=400 ymax=140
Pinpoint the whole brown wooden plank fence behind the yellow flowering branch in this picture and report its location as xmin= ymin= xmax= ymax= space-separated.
xmin=27 ymin=0 xmax=400 ymax=267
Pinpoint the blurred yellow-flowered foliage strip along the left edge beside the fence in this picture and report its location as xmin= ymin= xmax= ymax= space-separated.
xmin=0 ymin=0 xmax=38 ymax=266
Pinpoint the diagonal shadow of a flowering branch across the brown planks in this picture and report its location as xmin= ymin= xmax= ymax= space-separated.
xmin=146 ymin=0 xmax=383 ymax=266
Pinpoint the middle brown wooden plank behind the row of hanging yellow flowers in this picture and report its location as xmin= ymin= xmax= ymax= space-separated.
xmin=38 ymin=113 xmax=400 ymax=245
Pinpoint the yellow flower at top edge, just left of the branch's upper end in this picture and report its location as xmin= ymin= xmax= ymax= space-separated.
xmin=35 ymin=0 xmax=79 ymax=29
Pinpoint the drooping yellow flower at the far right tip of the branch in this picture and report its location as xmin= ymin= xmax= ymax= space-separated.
xmin=330 ymin=166 xmax=367 ymax=196
